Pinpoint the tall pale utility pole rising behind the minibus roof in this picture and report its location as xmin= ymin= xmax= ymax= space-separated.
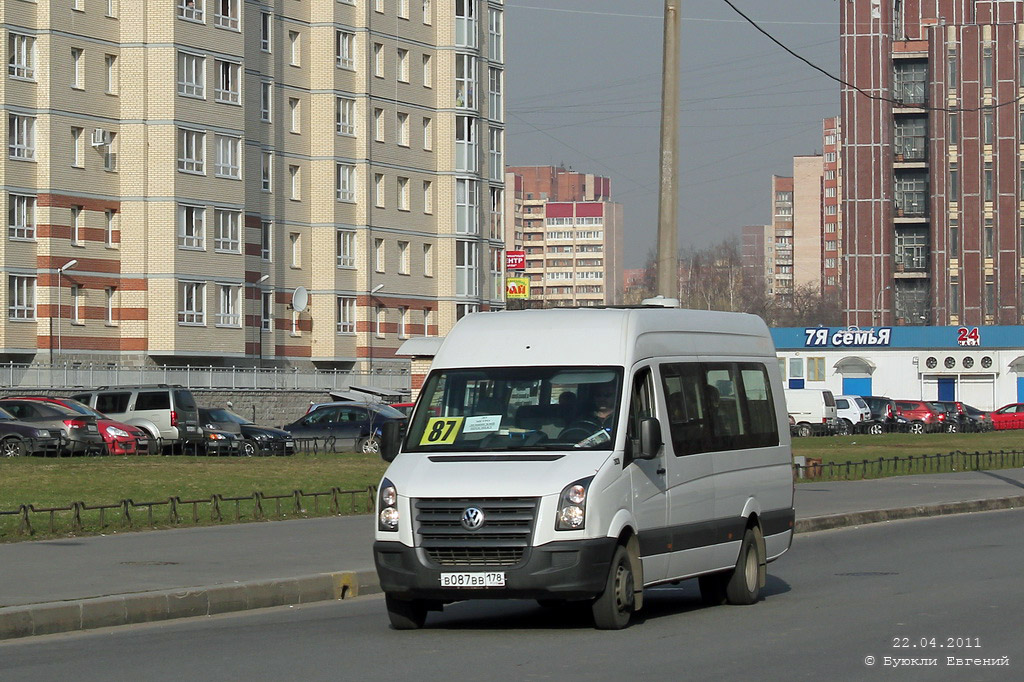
xmin=656 ymin=0 xmax=681 ymax=298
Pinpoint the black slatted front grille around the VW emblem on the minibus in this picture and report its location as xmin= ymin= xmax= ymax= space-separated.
xmin=415 ymin=498 xmax=538 ymax=566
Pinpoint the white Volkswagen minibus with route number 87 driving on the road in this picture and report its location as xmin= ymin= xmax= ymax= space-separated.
xmin=374 ymin=308 xmax=794 ymax=629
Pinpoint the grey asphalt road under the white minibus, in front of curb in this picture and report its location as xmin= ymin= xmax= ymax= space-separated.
xmin=0 ymin=510 xmax=1024 ymax=682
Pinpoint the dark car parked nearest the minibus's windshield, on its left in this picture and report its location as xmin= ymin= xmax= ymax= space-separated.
xmin=282 ymin=400 xmax=409 ymax=453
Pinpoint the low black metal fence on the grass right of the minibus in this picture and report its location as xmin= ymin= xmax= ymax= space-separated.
xmin=793 ymin=450 xmax=1024 ymax=480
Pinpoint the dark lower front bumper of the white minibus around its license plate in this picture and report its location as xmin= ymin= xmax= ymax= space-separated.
xmin=374 ymin=538 xmax=616 ymax=602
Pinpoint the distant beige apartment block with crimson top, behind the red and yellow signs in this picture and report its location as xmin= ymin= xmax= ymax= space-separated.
xmin=505 ymin=166 xmax=624 ymax=307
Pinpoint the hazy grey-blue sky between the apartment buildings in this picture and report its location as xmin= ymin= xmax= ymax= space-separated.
xmin=505 ymin=0 xmax=840 ymax=267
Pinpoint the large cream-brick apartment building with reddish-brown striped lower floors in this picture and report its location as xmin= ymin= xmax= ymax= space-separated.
xmin=0 ymin=0 xmax=505 ymax=369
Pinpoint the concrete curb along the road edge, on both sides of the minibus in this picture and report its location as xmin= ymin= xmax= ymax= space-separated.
xmin=0 ymin=496 xmax=1024 ymax=640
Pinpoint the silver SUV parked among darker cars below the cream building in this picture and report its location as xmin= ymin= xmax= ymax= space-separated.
xmin=72 ymin=384 xmax=204 ymax=451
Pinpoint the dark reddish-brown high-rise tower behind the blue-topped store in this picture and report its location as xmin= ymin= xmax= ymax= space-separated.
xmin=840 ymin=0 xmax=1024 ymax=326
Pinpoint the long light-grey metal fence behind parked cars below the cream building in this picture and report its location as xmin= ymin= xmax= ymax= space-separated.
xmin=0 ymin=363 xmax=412 ymax=393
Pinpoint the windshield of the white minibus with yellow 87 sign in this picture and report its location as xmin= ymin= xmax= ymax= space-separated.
xmin=402 ymin=367 xmax=623 ymax=453
